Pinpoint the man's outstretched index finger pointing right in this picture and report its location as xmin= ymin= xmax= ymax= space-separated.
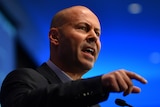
xmin=126 ymin=72 xmax=147 ymax=84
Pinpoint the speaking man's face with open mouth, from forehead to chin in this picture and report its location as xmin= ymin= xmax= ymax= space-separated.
xmin=59 ymin=7 xmax=101 ymax=71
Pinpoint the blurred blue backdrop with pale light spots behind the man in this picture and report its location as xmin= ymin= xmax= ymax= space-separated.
xmin=0 ymin=0 xmax=160 ymax=107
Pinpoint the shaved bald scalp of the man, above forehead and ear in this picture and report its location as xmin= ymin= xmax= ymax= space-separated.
xmin=50 ymin=6 xmax=98 ymax=28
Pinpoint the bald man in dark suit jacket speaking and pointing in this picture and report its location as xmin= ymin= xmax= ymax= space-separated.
xmin=1 ymin=6 xmax=147 ymax=107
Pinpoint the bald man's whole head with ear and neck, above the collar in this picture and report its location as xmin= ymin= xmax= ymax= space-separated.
xmin=49 ymin=6 xmax=101 ymax=76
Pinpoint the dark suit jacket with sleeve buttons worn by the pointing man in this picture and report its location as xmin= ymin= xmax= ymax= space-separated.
xmin=0 ymin=63 xmax=108 ymax=107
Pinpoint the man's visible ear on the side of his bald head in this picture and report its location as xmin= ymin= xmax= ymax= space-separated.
xmin=49 ymin=28 xmax=59 ymax=45
